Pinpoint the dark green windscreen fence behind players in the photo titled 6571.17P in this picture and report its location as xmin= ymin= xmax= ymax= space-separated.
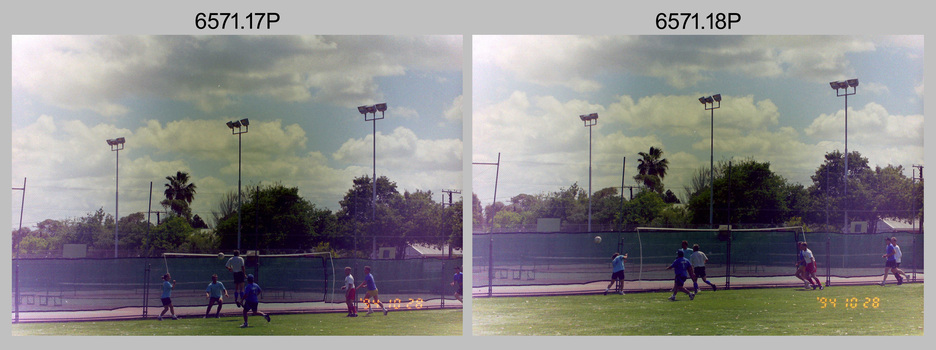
xmin=12 ymin=255 xmax=462 ymax=314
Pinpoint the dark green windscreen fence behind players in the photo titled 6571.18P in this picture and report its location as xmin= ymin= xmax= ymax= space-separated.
xmin=472 ymin=230 xmax=923 ymax=288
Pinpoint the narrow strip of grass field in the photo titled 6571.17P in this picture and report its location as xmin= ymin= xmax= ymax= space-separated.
xmin=12 ymin=309 xmax=462 ymax=336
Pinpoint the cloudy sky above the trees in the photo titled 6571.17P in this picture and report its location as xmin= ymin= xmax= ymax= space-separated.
xmin=11 ymin=36 xmax=463 ymax=228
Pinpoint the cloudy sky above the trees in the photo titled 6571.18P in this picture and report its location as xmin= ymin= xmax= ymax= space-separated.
xmin=471 ymin=36 xmax=924 ymax=205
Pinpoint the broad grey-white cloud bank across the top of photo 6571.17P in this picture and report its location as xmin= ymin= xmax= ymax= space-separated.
xmin=12 ymin=36 xmax=461 ymax=116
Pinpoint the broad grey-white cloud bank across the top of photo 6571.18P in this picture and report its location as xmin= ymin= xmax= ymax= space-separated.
xmin=472 ymin=36 xmax=888 ymax=92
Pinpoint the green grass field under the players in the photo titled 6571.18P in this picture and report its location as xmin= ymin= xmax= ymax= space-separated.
xmin=472 ymin=283 xmax=923 ymax=336
